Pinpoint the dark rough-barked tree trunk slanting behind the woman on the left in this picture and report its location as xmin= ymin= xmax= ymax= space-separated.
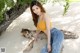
xmin=0 ymin=4 xmax=29 ymax=35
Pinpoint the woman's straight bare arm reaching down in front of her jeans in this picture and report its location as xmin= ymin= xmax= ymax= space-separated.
xmin=45 ymin=15 xmax=51 ymax=52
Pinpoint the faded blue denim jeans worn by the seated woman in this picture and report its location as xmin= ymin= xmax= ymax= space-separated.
xmin=41 ymin=28 xmax=64 ymax=53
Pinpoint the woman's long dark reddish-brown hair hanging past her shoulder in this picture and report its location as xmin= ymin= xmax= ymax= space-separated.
xmin=30 ymin=1 xmax=45 ymax=27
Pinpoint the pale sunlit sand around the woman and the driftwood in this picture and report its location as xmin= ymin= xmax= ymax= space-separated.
xmin=0 ymin=2 xmax=80 ymax=53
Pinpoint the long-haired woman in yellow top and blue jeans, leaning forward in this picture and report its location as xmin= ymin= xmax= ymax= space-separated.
xmin=30 ymin=1 xmax=64 ymax=53
